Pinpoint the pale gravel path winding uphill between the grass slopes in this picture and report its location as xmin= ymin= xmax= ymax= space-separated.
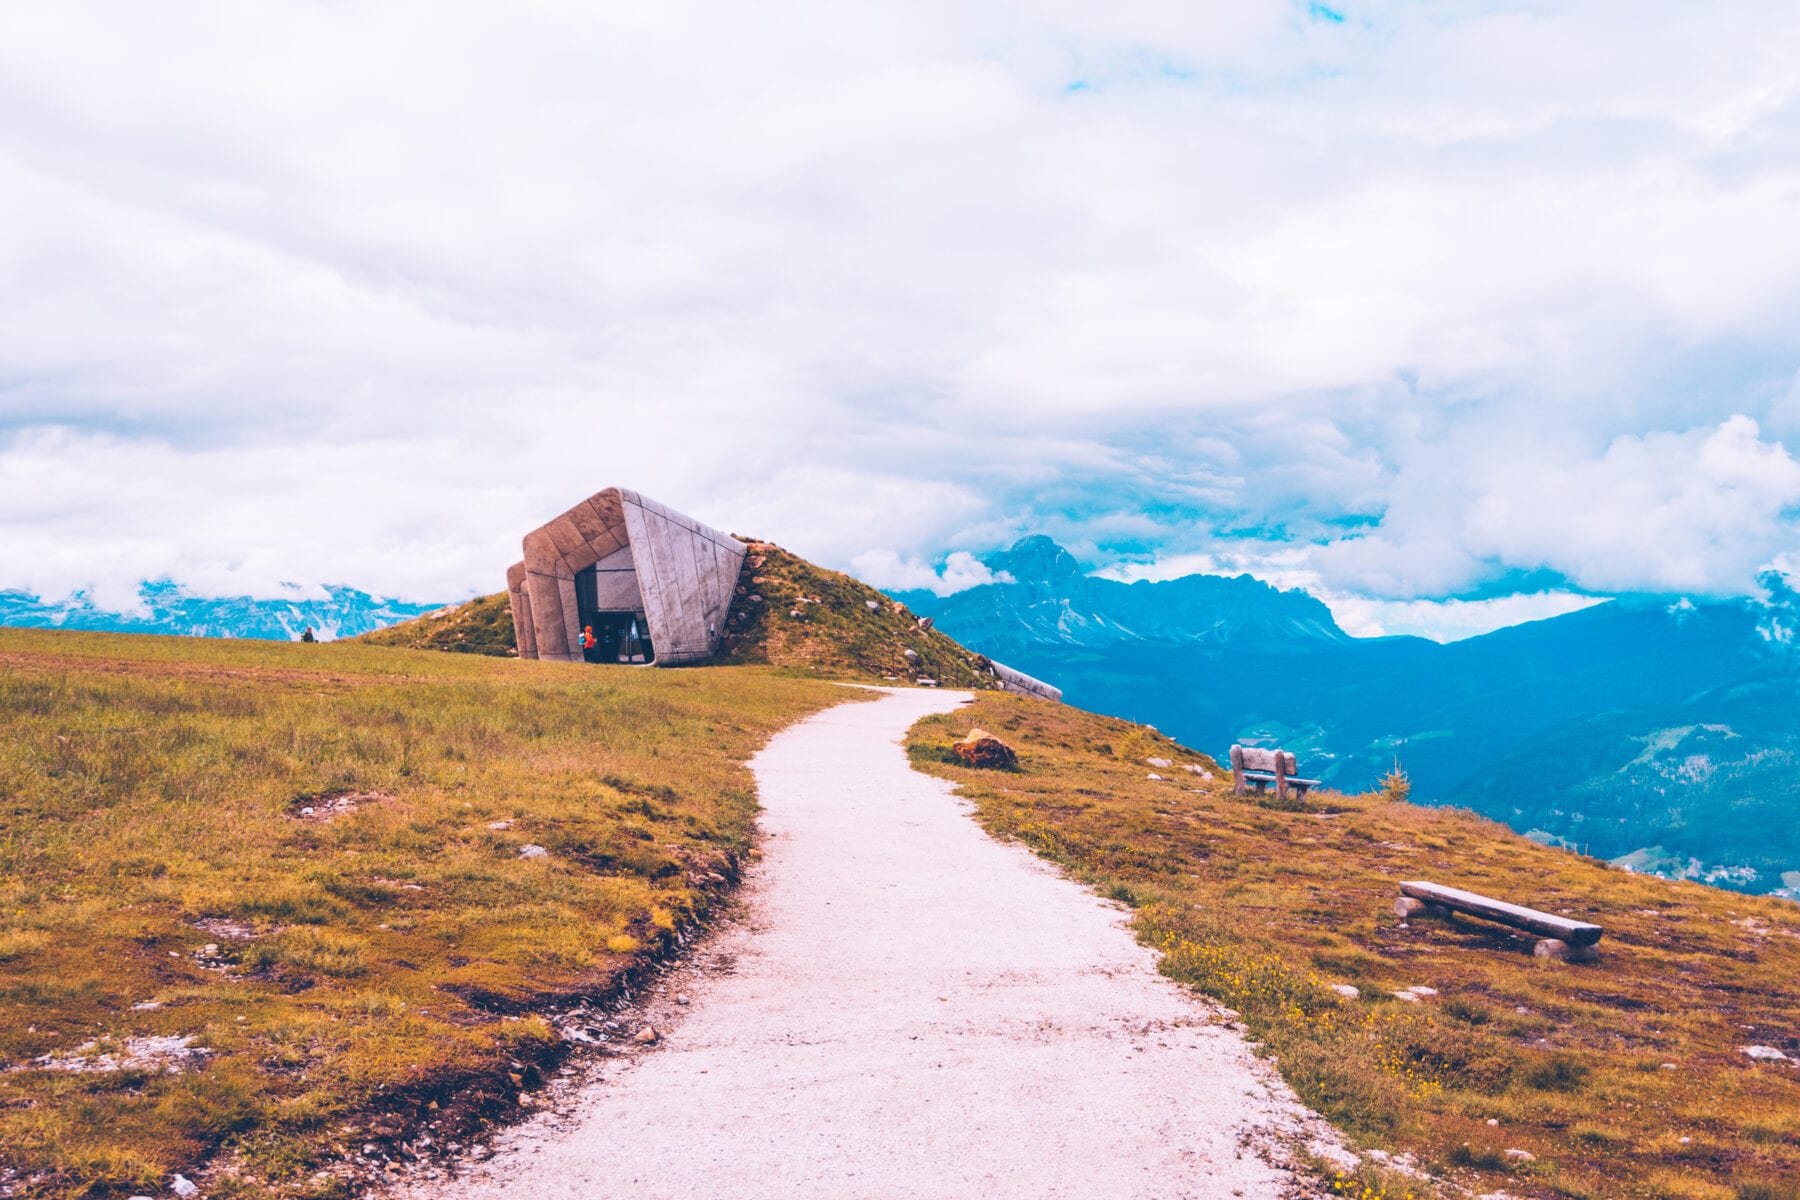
xmin=419 ymin=689 xmax=1328 ymax=1200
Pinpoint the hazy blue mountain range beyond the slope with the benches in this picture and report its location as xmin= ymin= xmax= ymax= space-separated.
xmin=904 ymin=536 xmax=1800 ymax=892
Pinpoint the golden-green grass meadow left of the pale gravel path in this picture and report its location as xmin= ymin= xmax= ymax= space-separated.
xmin=0 ymin=630 xmax=846 ymax=1196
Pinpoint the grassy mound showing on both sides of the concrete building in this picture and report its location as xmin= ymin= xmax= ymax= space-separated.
xmin=356 ymin=540 xmax=994 ymax=689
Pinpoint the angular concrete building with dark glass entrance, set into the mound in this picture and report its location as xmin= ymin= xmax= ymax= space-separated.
xmin=506 ymin=488 xmax=747 ymax=666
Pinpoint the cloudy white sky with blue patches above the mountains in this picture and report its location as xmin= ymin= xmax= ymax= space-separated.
xmin=0 ymin=0 xmax=1800 ymax=637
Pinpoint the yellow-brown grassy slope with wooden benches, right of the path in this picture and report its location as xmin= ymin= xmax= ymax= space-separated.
xmin=911 ymin=694 xmax=1800 ymax=1200
